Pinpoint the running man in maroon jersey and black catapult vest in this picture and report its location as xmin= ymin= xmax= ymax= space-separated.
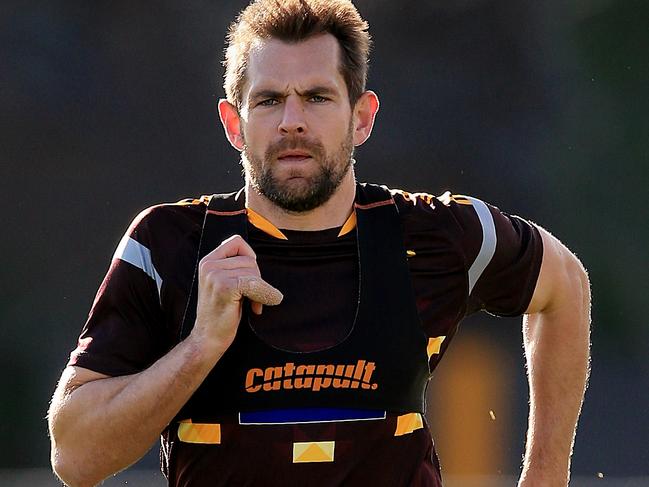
xmin=49 ymin=0 xmax=589 ymax=487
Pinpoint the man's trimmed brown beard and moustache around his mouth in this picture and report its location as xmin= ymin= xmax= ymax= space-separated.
xmin=241 ymin=124 xmax=354 ymax=213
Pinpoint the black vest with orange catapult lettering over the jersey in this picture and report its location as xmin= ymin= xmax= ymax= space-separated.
xmin=177 ymin=184 xmax=429 ymax=422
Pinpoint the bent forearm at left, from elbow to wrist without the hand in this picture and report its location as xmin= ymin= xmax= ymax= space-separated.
xmin=49 ymin=338 xmax=222 ymax=486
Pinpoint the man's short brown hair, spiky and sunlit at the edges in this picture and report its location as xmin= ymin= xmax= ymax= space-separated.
xmin=223 ymin=0 xmax=371 ymax=109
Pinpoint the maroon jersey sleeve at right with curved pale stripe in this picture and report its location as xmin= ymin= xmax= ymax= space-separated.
xmin=449 ymin=196 xmax=543 ymax=316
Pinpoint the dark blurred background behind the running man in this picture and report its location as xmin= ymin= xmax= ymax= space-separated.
xmin=0 ymin=0 xmax=649 ymax=485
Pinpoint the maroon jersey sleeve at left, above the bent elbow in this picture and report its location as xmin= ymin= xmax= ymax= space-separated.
xmin=68 ymin=209 xmax=162 ymax=376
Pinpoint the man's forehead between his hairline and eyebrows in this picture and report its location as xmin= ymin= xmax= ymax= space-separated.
xmin=244 ymin=34 xmax=346 ymax=98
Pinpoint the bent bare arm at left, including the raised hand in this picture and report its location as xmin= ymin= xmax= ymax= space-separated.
xmin=48 ymin=237 xmax=281 ymax=487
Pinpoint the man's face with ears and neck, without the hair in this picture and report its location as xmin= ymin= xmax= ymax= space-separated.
xmin=219 ymin=34 xmax=378 ymax=230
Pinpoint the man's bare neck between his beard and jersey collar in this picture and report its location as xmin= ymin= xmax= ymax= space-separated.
xmin=246 ymin=167 xmax=356 ymax=230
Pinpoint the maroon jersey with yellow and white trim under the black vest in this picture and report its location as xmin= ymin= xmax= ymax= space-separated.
xmin=70 ymin=185 xmax=542 ymax=487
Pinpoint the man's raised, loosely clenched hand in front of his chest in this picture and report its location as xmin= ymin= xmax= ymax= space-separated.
xmin=192 ymin=235 xmax=283 ymax=351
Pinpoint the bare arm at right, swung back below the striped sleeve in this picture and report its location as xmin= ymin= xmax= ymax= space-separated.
xmin=519 ymin=229 xmax=590 ymax=487
